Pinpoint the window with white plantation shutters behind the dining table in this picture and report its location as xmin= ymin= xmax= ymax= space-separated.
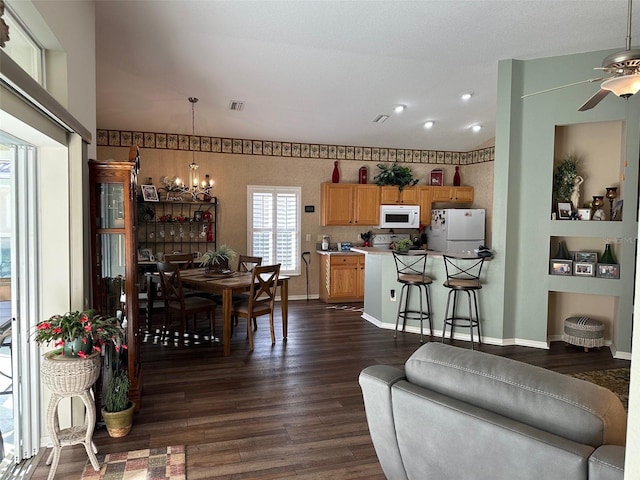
xmin=247 ymin=185 xmax=301 ymax=275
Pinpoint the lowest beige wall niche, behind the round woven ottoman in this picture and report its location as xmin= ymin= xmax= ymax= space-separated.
xmin=547 ymin=291 xmax=619 ymax=343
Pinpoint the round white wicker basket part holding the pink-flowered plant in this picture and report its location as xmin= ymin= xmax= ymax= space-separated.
xmin=40 ymin=352 xmax=100 ymax=395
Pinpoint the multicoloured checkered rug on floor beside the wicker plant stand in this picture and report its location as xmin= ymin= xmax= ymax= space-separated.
xmin=82 ymin=445 xmax=187 ymax=480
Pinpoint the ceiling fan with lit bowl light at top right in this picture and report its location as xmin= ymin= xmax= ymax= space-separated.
xmin=522 ymin=0 xmax=640 ymax=112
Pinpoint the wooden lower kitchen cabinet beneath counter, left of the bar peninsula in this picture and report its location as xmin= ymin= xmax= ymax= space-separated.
xmin=320 ymin=254 xmax=364 ymax=303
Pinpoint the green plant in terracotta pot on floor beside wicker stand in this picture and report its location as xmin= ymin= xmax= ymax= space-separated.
xmin=100 ymin=369 xmax=136 ymax=438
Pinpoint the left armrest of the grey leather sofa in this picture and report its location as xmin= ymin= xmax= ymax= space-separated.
xmin=359 ymin=365 xmax=407 ymax=480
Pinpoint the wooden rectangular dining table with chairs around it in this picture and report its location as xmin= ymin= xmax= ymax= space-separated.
xmin=174 ymin=268 xmax=289 ymax=357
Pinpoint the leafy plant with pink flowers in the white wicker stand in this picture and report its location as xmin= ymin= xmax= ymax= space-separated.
xmin=35 ymin=310 xmax=127 ymax=358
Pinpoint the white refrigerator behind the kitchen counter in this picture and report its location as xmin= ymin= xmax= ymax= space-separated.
xmin=427 ymin=208 xmax=485 ymax=254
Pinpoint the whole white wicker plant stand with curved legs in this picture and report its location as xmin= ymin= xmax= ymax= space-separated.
xmin=40 ymin=352 xmax=101 ymax=480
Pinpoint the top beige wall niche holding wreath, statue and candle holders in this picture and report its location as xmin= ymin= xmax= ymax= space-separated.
xmin=552 ymin=121 xmax=626 ymax=220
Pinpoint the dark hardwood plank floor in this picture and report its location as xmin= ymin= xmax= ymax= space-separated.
xmin=32 ymin=300 xmax=629 ymax=480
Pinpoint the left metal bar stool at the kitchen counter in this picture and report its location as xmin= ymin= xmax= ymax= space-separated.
xmin=393 ymin=252 xmax=433 ymax=343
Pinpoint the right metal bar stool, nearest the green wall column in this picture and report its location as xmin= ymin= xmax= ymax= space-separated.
xmin=442 ymin=255 xmax=485 ymax=350
